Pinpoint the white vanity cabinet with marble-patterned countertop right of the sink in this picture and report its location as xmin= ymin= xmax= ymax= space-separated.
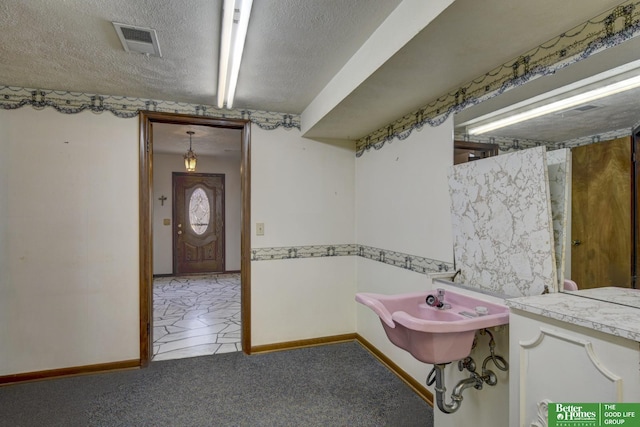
xmin=507 ymin=294 xmax=640 ymax=427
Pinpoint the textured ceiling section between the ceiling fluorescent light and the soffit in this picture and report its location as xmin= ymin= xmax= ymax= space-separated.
xmin=235 ymin=0 xmax=400 ymax=113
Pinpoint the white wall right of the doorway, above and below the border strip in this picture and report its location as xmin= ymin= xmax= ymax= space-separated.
xmin=251 ymin=126 xmax=355 ymax=345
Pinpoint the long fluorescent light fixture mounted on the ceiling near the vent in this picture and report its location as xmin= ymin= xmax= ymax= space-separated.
xmin=218 ymin=0 xmax=253 ymax=108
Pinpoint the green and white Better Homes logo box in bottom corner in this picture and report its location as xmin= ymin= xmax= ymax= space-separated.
xmin=548 ymin=403 xmax=640 ymax=427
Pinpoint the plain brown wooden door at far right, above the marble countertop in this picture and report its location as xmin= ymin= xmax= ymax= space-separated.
xmin=571 ymin=137 xmax=633 ymax=289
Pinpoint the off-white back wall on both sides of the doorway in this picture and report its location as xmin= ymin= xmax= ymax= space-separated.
xmin=0 ymin=108 xmax=355 ymax=375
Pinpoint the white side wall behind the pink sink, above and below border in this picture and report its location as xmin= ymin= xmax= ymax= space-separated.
xmin=356 ymin=119 xmax=453 ymax=383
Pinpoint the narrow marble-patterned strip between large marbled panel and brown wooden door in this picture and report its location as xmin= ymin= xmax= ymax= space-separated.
xmin=547 ymin=148 xmax=571 ymax=285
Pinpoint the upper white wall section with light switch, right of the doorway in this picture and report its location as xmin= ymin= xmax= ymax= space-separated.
xmin=251 ymin=126 xmax=355 ymax=248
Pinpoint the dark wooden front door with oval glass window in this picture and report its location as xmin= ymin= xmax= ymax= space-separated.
xmin=173 ymin=172 xmax=225 ymax=274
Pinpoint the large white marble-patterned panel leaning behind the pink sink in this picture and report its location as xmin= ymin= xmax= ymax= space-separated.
xmin=449 ymin=147 xmax=557 ymax=297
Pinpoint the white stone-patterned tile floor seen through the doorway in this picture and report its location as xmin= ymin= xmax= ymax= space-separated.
xmin=152 ymin=273 xmax=242 ymax=361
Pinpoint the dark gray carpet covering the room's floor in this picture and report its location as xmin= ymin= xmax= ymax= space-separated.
xmin=0 ymin=342 xmax=433 ymax=427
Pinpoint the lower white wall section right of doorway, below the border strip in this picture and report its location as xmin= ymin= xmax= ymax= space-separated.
xmin=251 ymin=256 xmax=355 ymax=345
